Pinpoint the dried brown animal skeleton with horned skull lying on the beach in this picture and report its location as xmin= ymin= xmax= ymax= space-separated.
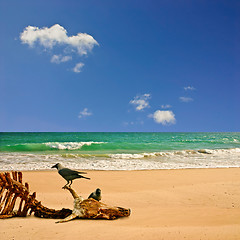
xmin=0 ymin=172 xmax=130 ymax=222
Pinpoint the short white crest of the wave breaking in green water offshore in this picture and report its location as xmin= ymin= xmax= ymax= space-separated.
xmin=44 ymin=142 xmax=104 ymax=150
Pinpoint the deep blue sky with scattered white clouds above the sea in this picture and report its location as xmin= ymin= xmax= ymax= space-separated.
xmin=0 ymin=0 xmax=240 ymax=132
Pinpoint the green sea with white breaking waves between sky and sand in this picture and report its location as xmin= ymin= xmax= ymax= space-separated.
xmin=0 ymin=132 xmax=240 ymax=171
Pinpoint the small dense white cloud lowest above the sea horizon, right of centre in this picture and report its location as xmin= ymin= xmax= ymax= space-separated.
xmin=148 ymin=110 xmax=176 ymax=125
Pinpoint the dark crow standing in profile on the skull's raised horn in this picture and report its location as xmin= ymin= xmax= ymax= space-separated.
xmin=52 ymin=163 xmax=90 ymax=188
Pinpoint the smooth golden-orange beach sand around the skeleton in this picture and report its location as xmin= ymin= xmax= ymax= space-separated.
xmin=0 ymin=168 xmax=240 ymax=240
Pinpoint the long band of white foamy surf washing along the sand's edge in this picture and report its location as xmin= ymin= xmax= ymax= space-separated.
xmin=0 ymin=148 xmax=240 ymax=171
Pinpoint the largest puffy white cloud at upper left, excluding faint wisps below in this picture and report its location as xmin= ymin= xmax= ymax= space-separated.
xmin=20 ymin=24 xmax=99 ymax=55
